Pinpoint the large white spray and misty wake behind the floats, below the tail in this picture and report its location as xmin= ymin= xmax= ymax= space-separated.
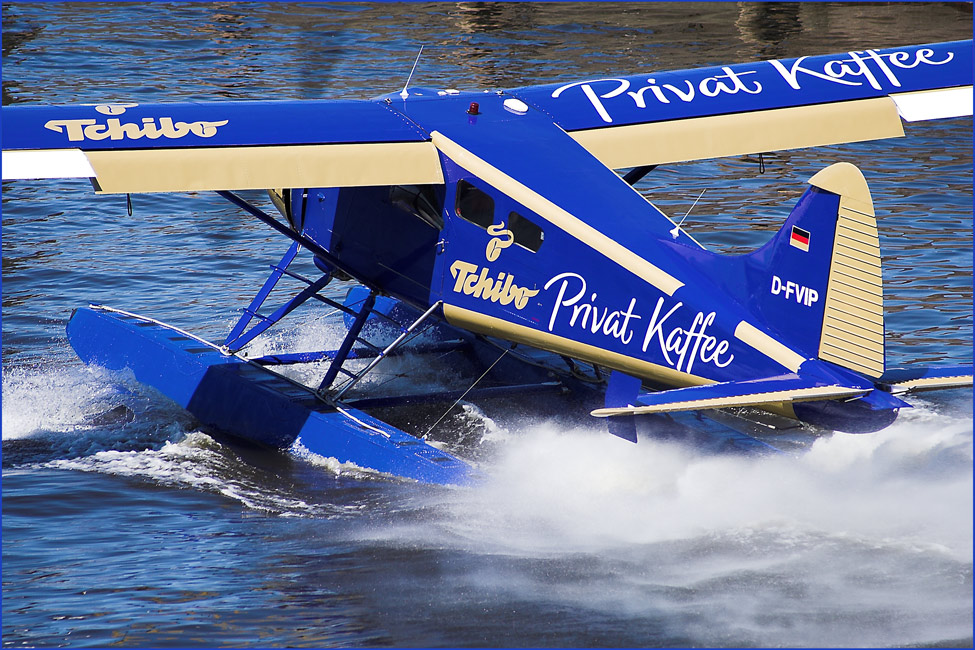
xmin=342 ymin=402 xmax=973 ymax=646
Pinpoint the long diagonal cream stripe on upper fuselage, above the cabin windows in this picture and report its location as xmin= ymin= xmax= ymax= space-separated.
xmin=431 ymin=131 xmax=684 ymax=296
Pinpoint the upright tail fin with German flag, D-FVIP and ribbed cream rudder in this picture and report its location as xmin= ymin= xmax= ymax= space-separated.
xmin=699 ymin=163 xmax=884 ymax=378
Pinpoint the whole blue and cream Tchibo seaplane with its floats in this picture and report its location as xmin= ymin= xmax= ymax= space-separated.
xmin=2 ymin=40 xmax=973 ymax=484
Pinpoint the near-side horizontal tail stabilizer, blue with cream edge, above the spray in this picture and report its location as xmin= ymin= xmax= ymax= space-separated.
xmin=592 ymin=375 xmax=871 ymax=417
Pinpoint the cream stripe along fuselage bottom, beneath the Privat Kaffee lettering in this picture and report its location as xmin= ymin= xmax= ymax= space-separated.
xmin=443 ymin=304 xmax=715 ymax=386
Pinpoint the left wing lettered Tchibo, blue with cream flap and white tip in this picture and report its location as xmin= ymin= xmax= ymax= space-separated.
xmin=3 ymin=100 xmax=443 ymax=193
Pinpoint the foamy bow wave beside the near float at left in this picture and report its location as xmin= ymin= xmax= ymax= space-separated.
xmin=3 ymin=366 xmax=368 ymax=517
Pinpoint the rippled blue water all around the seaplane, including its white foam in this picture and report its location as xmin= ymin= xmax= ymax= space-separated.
xmin=3 ymin=3 xmax=973 ymax=647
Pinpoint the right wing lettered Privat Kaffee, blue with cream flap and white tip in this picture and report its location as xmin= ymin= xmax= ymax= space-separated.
xmin=506 ymin=40 xmax=972 ymax=169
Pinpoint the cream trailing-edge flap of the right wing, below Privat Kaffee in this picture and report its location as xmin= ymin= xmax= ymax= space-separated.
xmin=570 ymin=97 xmax=904 ymax=169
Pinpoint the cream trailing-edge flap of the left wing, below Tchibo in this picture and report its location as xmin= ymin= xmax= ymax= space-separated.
xmin=86 ymin=142 xmax=444 ymax=193
